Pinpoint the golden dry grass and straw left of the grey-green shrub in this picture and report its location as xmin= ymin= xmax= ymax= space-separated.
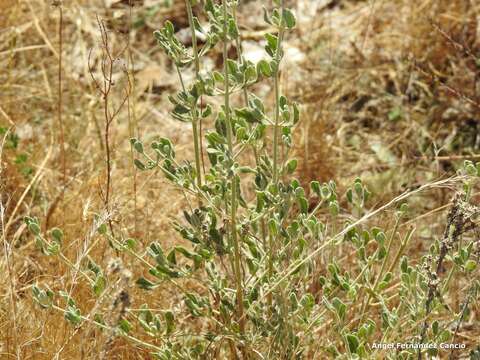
xmin=0 ymin=1 xmax=190 ymax=359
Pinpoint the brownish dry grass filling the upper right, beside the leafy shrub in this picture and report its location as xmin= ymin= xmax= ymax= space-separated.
xmin=297 ymin=0 xmax=480 ymax=348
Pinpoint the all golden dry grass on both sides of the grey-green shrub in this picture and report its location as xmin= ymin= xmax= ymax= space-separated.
xmin=0 ymin=0 xmax=480 ymax=359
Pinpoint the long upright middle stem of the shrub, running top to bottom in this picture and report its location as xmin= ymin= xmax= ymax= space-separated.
xmin=222 ymin=0 xmax=245 ymax=334
